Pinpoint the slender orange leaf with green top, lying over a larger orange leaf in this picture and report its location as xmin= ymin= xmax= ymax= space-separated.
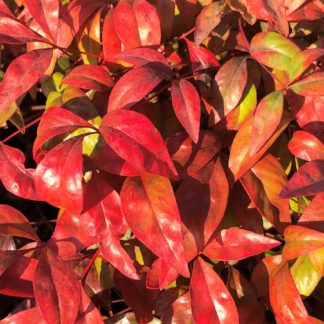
xmin=249 ymin=91 xmax=284 ymax=156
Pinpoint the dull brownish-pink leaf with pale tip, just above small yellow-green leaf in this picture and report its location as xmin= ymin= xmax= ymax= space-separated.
xmin=215 ymin=56 xmax=248 ymax=116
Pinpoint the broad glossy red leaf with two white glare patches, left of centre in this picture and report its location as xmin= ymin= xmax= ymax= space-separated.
xmin=35 ymin=136 xmax=83 ymax=214
